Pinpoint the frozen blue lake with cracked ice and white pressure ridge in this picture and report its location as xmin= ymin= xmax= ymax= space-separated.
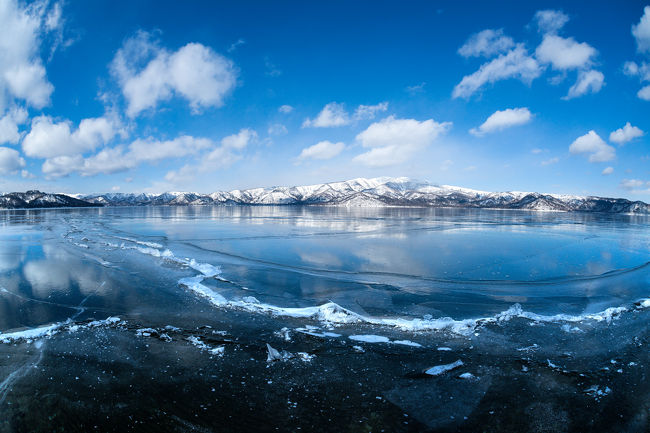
xmin=0 ymin=206 xmax=650 ymax=431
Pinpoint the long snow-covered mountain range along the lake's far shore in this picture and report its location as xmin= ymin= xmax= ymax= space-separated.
xmin=76 ymin=177 xmax=650 ymax=214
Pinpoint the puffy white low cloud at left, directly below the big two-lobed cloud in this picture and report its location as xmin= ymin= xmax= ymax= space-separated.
xmin=22 ymin=116 xmax=123 ymax=158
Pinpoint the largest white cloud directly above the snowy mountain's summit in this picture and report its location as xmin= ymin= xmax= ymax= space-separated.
xmin=353 ymin=116 xmax=451 ymax=167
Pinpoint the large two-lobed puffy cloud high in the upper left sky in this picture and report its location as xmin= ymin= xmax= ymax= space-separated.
xmin=110 ymin=32 xmax=238 ymax=117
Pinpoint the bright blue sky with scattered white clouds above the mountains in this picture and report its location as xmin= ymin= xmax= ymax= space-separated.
xmin=0 ymin=0 xmax=650 ymax=197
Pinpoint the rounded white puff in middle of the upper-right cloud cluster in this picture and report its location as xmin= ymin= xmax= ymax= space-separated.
xmin=535 ymin=34 xmax=598 ymax=71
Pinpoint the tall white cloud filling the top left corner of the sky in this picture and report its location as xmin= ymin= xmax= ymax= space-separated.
xmin=0 ymin=0 xmax=61 ymax=110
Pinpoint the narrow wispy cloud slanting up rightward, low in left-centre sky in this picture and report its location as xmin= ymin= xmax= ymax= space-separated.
xmin=165 ymin=128 xmax=258 ymax=184
